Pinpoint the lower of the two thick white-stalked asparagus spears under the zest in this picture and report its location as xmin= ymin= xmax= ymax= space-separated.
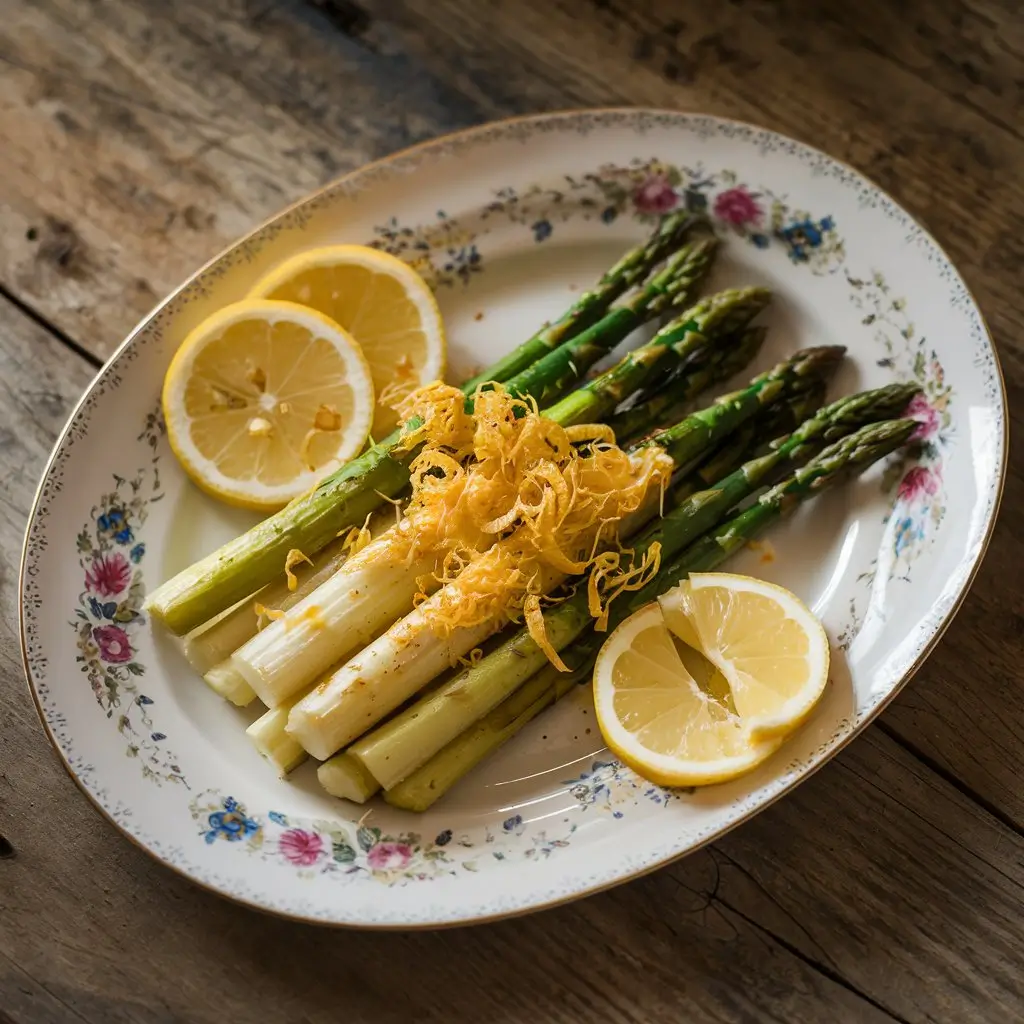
xmin=299 ymin=347 xmax=844 ymax=770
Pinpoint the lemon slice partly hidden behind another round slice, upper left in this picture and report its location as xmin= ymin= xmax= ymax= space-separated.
xmin=249 ymin=246 xmax=445 ymax=440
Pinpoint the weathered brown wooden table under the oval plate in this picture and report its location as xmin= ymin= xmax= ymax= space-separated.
xmin=0 ymin=0 xmax=1024 ymax=1024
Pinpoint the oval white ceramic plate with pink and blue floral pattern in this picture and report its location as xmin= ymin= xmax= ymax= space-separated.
xmin=22 ymin=111 xmax=1007 ymax=927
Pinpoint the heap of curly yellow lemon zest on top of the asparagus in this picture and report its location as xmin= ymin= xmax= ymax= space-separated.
xmin=376 ymin=381 xmax=672 ymax=657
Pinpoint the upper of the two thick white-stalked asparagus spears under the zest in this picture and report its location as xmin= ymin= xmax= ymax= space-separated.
xmin=231 ymin=289 xmax=768 ymax=707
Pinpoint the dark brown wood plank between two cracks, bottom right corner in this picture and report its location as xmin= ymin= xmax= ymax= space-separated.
xmin=710 ymin=729 xmax=1024 ymax=1021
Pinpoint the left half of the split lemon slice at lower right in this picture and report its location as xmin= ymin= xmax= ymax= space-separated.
xmin=594 ymin=602 xmax=781 ymax=785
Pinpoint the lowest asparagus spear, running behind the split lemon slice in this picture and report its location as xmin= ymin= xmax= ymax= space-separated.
xmin=387 ymin=420 xmax=914 ymax=811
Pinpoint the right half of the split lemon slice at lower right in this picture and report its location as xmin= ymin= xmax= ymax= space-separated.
xmin=658 ymin=572 xmax=828 ymax=737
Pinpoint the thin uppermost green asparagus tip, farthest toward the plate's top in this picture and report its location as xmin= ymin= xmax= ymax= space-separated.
xmin=463 ymin=212 xmax=698 ymax=394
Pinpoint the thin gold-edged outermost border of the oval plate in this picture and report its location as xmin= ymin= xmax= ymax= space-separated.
xmin=18 ymin=106 xmax=1009 ymax=930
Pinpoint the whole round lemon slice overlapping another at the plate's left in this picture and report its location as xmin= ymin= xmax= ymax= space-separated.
xmin=162 ymin=300 xmax=374 ymax=510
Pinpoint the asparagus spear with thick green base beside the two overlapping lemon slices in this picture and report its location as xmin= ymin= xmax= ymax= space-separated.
xmin=146 ymin=239 xmax=715 ymax=636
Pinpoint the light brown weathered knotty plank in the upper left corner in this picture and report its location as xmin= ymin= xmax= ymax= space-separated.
xmin=0 ymin=0 xmax=485 ymax=355
